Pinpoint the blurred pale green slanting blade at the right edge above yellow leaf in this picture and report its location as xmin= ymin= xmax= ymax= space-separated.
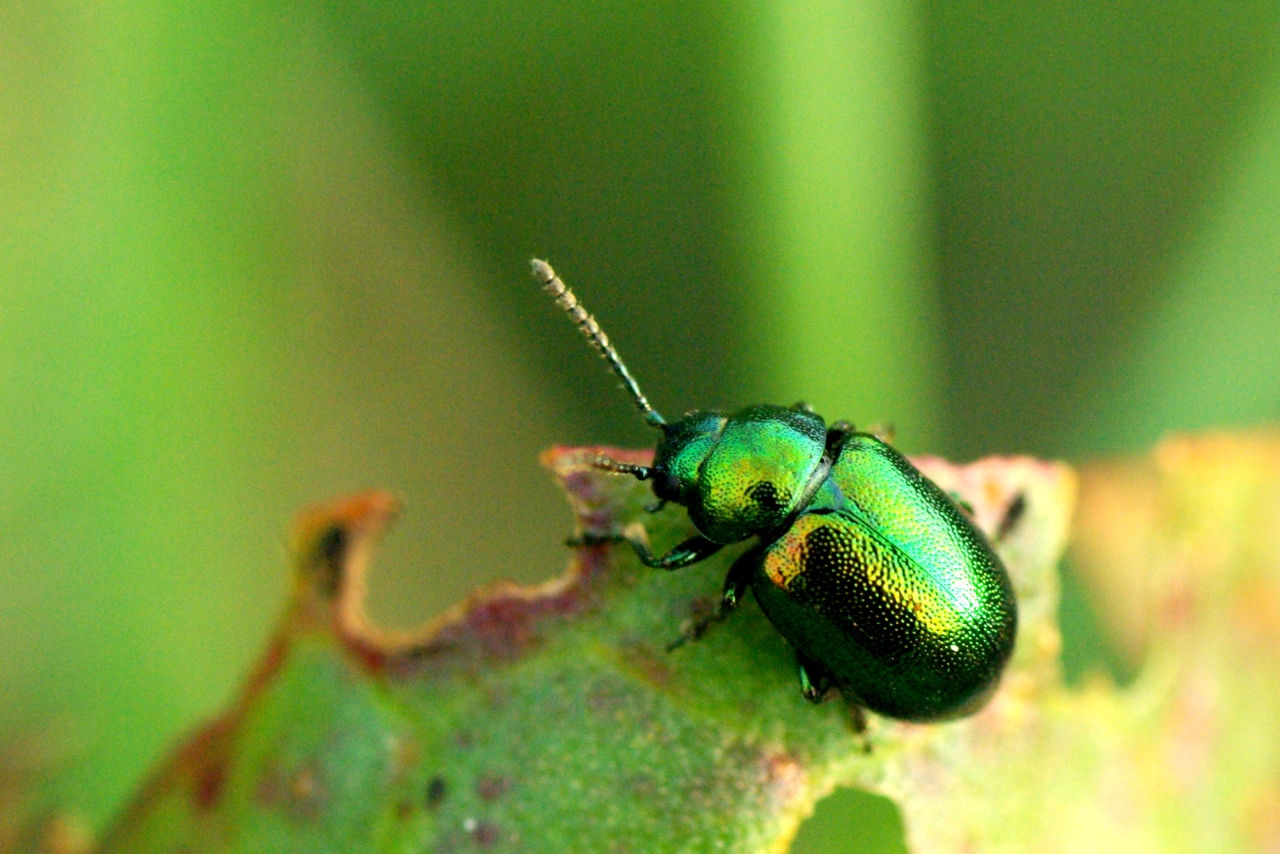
xmin=1070 ymin=63 xmax=1280 ymax=449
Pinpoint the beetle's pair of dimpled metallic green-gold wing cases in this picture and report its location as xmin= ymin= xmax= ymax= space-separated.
xmin=751 ymin=434 xmax=1018 ymax=721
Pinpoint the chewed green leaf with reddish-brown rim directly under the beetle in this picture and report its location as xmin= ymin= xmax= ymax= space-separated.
xmin=102 ymin=448 xmax=1074 ymax=853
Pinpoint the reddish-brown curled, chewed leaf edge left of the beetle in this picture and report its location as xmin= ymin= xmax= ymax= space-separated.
xmin=101 ymin=447 xmax=653 ymax=846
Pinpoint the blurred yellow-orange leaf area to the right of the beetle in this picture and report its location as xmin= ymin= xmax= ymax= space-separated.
xmin=881 ymin=433 xmax=1280 ymax=851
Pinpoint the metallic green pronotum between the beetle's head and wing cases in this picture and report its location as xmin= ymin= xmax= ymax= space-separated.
xmin=687 ymin=406 xmax=827 ymax=543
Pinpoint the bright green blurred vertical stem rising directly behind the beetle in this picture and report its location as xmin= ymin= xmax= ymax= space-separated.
xmin=742 ymin=0 xmax=943 ymax=448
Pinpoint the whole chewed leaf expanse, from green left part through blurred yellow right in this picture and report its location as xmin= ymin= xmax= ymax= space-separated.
xmin=42 ymin=434 xmax=1280 ymax=854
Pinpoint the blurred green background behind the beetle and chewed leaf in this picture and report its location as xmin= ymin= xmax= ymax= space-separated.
xmin=0 ymin=0 xmax=1280 ymax=851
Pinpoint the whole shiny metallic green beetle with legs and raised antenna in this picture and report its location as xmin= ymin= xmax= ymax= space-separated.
xmin=532 ymin=260 xmax=1018 ymax=722
